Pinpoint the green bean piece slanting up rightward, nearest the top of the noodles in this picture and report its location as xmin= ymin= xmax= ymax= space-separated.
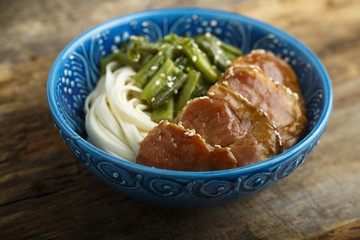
xmin=140 ymin=58 xmax=175 ymax=105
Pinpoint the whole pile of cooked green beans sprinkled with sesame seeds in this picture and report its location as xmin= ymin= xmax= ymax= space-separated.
xmin=100 ymin=33 xmax=242 ymax=122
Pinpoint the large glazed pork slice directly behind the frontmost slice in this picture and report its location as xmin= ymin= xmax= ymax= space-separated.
xmin=177 ymin=85 xmax=282 ymax=167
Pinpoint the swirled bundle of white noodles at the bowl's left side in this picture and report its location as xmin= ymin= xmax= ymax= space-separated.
xmin=84 ymin=62 xmax=157 ymax=162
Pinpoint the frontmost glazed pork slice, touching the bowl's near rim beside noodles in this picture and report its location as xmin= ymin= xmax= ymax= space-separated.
xmin=136 ymin=121 xmax=236 ymax=171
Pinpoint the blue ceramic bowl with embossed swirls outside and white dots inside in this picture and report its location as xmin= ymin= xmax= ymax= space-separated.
xmin=47 ymin=8 xmax=332 ymax=207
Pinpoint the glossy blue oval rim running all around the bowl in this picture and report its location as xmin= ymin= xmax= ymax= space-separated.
xmin=47 ymin=8 xmax=333 ymax=177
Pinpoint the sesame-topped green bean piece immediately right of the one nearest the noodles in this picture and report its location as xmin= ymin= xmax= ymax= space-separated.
xmin=152 ymin=72 xmax=187 ymax=109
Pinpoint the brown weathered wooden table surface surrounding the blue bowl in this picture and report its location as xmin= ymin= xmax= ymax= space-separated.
xmin=0 ymin=0 xmax=360 ymax=239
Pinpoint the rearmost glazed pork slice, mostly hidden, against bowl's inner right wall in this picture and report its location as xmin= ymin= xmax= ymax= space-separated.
xmin=231 ymin=49 xmax=305 ymax=111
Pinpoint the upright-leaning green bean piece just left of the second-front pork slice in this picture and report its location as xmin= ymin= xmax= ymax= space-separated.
xmin=175 ymin=70 xmax=201 ymax=113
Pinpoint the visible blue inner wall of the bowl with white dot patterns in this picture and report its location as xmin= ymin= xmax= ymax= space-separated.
xmin=48 ymin=9 xmax=331 ymax=164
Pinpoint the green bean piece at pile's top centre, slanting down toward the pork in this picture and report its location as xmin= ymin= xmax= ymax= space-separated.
xmin=181 ymin=38 xmax=219 ymax=83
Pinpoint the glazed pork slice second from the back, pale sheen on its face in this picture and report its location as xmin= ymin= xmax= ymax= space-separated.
xmin=218 ymin=66 xmax=307 ymax=150
